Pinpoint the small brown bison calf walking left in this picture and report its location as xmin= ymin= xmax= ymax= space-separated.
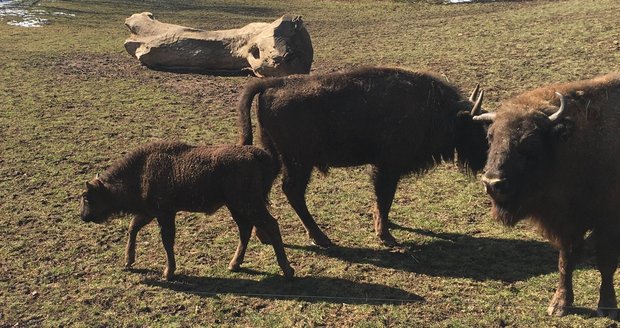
xmin=81 ymin=142 xmax=294 ymax=279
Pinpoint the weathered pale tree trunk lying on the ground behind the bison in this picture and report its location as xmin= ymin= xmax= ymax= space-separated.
xmin=125 ymin=12 xmax=313 ymax=76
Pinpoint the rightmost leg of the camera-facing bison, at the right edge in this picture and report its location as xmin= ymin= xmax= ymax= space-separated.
xmin=594 ymin=231 xmax=618 ymax=319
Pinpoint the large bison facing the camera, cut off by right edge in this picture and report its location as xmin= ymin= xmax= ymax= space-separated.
xmin=474 ymin=73 xmax=620 ymax=317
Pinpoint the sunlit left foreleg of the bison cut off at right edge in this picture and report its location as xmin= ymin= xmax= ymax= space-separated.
xmin=547 ymin=245 xmax=576 ymax=316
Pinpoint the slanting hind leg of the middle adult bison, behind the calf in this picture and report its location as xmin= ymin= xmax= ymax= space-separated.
xmin=282 ymin=164 xmax=333 ymax=247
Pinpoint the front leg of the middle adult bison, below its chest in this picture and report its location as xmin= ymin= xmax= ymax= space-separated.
xmin=373 ymin=167 xmax=400 ymax=246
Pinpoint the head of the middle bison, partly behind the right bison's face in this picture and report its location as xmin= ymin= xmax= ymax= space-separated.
xmin=456 ymin=85 xmax=489 ymax=173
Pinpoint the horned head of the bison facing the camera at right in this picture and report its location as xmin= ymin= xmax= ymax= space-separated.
xmin=474 ymin=93 xmax=570 ymax=225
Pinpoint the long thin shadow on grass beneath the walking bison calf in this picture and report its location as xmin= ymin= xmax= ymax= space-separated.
xmin=143 ymin=274 xmax=424 ymax=304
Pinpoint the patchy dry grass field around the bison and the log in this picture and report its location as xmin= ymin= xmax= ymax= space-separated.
xmin=0 ymin=0 xmax=620 ymax=327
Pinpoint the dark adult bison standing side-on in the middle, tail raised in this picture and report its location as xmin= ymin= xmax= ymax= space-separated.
xmin=238 ymin=67 xmax=488 ymax=247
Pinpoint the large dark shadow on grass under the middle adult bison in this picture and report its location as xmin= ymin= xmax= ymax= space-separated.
xmin=288 ymin=224 xmax=580 ymax=283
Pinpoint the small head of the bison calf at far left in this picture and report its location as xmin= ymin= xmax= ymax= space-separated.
xmin=80 ymin=176 xmax=113 ymax=223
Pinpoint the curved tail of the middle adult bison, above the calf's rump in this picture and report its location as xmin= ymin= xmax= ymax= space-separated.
xmin=237 ymin=78 xmax=284 ymax=145
